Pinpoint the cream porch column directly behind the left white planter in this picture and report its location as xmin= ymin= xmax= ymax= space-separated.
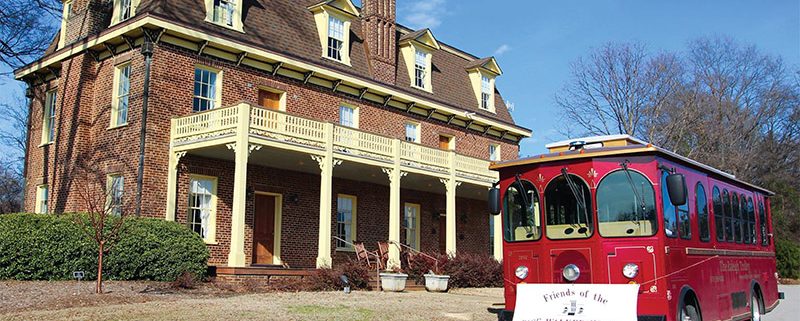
xmin=383 ymin=139 xmax=407 ymax=269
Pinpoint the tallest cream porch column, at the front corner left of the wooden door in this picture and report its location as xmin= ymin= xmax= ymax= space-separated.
xmin=227 ymin=104 xmax=252 ymax=267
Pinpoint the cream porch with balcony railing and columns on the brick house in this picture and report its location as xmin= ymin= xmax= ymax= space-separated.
xmin=166 ymin=104 xmax=500 ymax=268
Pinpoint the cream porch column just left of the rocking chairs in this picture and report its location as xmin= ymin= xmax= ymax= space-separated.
xmin=311 ymin=123 xmax=342 ymax=269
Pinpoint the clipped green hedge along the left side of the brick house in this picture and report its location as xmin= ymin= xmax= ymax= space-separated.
xmin=0 ymin=214 xmax=209 ymax=281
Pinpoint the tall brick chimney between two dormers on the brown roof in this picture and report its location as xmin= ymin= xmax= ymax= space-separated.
xmin=361 ymin=0 xmax=397 ymax=84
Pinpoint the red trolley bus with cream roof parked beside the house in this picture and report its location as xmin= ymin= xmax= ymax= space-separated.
xmin=489 ymin=135 xmax=779 ymax=321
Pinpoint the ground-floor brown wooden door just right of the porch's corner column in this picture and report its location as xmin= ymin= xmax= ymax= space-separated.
xmin=253 ymin=195 xmax=276 ymax=264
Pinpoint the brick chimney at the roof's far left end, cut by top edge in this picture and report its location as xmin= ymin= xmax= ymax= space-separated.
xmin=62 ymin=0 xmax=113 ymax=45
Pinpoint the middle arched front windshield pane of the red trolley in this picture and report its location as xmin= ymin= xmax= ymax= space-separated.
xmin=544 ymin=175 xmax=593 ymax=239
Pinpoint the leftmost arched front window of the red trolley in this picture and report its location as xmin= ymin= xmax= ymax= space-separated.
xmin=503 ymin=180 xmax=542 ymax=242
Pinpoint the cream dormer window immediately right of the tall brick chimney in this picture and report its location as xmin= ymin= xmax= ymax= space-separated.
xmin=400 ymin=29 xmax=441 ymax=92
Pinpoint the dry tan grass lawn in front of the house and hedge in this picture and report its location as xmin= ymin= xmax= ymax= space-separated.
xmin=0 ymin=282 xmax=503 ymax=321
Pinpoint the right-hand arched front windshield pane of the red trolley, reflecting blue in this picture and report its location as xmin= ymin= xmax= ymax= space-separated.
xmin=597 ymin=170 xmax=658 ymax=237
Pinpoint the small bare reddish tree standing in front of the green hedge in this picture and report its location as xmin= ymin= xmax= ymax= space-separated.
xmin=73 ymin=167 xmax=133 ymax=294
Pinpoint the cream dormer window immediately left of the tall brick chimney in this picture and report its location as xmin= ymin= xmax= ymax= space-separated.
xmin=308 ymin=0 xmax=360 ymax=66
